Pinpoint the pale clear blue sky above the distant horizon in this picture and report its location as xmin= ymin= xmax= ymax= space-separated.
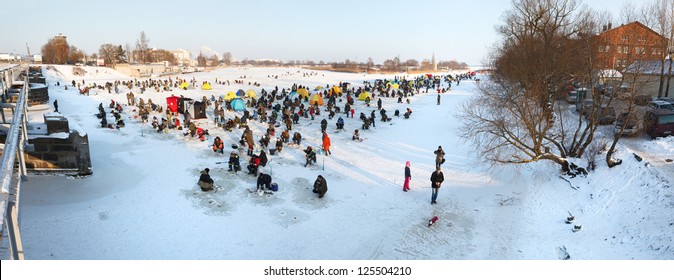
xmin=0 ymin=0 xmax=632 ymax=65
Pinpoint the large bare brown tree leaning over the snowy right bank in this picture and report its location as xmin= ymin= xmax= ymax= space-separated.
xmin=460 ymin=0 xmax=610 ymax=172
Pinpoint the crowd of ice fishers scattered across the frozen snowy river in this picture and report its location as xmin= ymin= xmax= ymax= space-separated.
xmin=73 ymin=72 xmax=473 ymax=204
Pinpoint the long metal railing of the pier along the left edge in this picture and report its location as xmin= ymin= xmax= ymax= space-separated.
xmin=0 ymin=64 xmax=30 ymax=260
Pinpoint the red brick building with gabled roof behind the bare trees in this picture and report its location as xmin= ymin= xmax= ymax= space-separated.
xmin=595 ymin=21 xmax=668 ymax=71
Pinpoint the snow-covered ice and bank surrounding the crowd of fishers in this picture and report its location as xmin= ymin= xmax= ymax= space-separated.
xmin=6 ymin=66 xmax=674 ymax=260
